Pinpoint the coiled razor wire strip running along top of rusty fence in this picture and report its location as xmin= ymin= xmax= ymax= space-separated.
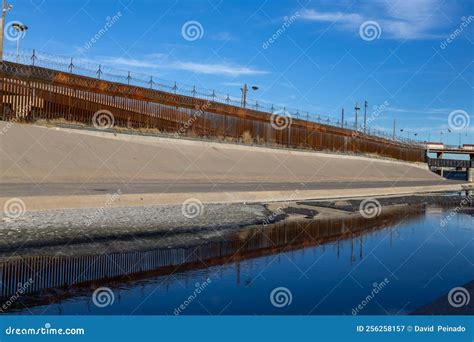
xmin=3 ymin=50 xmax=420 ymax=145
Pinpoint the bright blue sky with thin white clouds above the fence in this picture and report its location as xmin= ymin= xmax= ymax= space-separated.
xmin=5 ymin=0 xmax=474 ymax=144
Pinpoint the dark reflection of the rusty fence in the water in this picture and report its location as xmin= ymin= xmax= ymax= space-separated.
xmin=0 ymin=212 xmax=420 ymax=298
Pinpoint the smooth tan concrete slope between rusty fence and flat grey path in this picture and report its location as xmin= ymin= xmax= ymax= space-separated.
xmin=0 ymin=122 xmax=441 ymax=182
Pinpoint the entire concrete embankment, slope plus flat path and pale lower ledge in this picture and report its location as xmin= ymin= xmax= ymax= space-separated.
xmin=0 ymin=122 xmax=466 ymax=208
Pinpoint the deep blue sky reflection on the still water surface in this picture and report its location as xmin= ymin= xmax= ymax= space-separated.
xmin=14 ymin=213 xmax=474 ymax=315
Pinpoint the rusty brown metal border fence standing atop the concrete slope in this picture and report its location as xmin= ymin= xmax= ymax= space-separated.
xmin=0 ymin=52 xmax=425 ymax=162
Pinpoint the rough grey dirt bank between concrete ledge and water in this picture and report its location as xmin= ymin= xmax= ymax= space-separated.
xmin=0 ymin=194 xmax=467 ymax=259
